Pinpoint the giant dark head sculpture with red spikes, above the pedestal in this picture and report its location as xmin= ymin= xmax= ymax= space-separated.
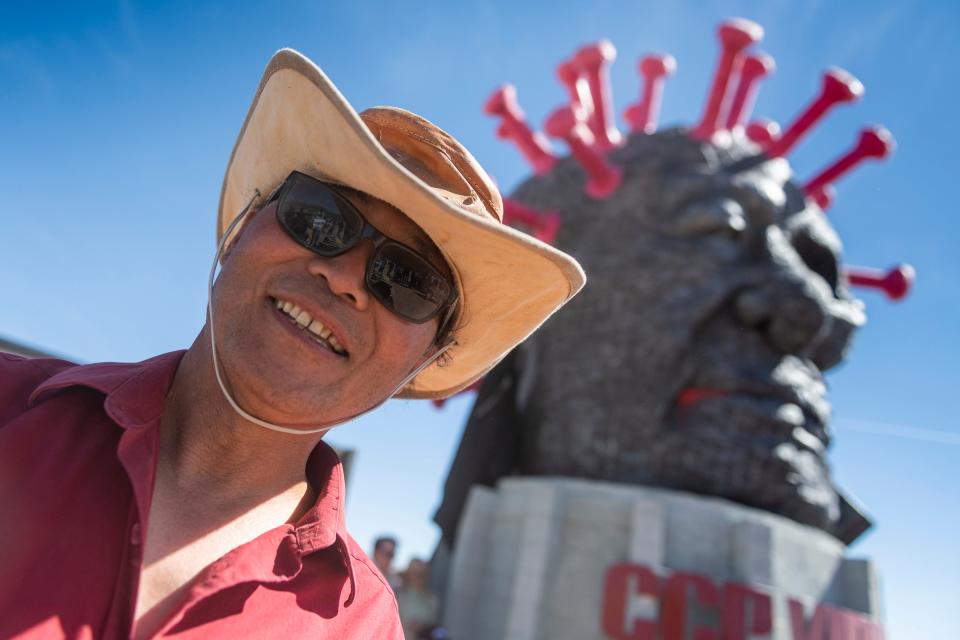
xmin=436 ymin=21 xmax=908 ymax=545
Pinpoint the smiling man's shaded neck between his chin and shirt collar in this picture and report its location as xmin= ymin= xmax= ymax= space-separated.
xmin=158 ymin=330 xmax=321 ymax=503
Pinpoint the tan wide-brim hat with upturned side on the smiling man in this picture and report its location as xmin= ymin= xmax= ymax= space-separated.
xmin=217 ymin=49 xmax=585 ymax=398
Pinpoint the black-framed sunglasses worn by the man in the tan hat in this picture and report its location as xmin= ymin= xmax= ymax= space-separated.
xmin=268 ymin=171 xmax=457 ymax=334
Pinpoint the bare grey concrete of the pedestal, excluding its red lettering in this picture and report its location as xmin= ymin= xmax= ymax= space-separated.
xmin=445 ymin=478 xmax=882 ymax=640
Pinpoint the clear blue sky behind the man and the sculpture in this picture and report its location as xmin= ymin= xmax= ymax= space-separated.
xmin=0 ymin=0 xmax=960 ymax=638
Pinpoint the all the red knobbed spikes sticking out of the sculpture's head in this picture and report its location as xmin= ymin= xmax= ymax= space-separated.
xmin=484 ymin=18 xmax=913 ymax=308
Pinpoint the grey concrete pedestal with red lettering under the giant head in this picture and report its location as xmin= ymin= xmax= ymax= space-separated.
xmin=445 ymin=477 xmax=881 ymax=640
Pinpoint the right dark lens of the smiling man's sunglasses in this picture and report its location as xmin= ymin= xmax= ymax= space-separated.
xmin=367 ymin=242 xmax=451 ymax=322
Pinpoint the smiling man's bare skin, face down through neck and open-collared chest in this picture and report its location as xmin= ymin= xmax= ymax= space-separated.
xmin=134 ymin=188 xmax=448 ymax=638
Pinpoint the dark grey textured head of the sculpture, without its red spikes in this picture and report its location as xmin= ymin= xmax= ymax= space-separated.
xmin=512 ymin=129 xmax=864 ymax=531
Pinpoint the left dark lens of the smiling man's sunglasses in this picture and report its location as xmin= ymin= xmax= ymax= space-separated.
xmin=277 ymin=181 xmax=363 ymax=256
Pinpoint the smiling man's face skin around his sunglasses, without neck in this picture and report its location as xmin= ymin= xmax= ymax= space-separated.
xmin=212 ymin=184 xmax=447 ymax=427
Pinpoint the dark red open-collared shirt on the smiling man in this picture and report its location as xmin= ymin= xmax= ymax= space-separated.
xmin=0 ymin=351 xmax=403 ymax=640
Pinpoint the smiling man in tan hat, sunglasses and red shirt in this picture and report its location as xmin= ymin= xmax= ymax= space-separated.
xmin=0 ymin=50 xmax=583 ymax=640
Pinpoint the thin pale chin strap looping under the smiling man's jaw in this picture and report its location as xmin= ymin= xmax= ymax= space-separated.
xmin=207 ymin=190 xmax=456 ymax=436
